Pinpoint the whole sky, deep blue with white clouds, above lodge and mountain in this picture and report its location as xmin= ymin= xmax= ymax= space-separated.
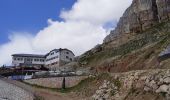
xmin=0 ymin=0 xmax=132 ymax=66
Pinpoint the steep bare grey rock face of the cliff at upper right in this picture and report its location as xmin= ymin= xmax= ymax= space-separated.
xmin=104 ymin=0 xmax=170 ymax=43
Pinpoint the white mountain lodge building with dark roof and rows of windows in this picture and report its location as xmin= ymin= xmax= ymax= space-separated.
xmin=12 ymin=48 xmax=75 ymax=70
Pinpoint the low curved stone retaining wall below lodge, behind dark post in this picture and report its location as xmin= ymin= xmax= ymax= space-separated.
xmin=25 ymin=76 xmax=87 ymax=88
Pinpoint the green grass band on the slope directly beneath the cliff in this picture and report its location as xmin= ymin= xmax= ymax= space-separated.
xmin=79 ymin=22 xmax=170 ymax=66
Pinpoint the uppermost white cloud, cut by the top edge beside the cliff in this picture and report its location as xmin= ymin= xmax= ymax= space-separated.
xmin=61 ymin=0 xmax=132 ymax=24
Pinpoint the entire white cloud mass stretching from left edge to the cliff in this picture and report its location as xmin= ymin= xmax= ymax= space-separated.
xmin=0 ymin=0 xmax=132 ymax=65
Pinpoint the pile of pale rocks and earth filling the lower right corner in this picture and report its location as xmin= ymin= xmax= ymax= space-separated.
xmin=91 ymin=69 xmax=170 ymax=100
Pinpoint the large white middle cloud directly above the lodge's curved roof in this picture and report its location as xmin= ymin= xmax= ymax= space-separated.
xmin=33 ymin=21 xmax=106 ymax=55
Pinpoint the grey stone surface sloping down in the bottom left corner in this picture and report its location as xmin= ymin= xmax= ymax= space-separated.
xmin=0 ymin=80 xmax=34 ymax=100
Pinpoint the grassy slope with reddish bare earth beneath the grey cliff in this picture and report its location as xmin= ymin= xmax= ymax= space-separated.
xmin=79 ymin=22 xmax=170 ymax=72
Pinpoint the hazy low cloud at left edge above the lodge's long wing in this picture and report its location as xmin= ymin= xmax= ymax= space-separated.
xmin=0 ymin=33 xmax=34 ymax=65
